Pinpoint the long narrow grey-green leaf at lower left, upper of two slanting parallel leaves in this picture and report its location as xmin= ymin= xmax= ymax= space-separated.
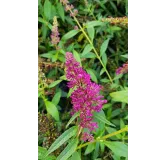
xmin=45 ymin=126 xmax=78 ymax=156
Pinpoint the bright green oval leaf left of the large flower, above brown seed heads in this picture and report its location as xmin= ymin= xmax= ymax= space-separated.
xmin=45 ymin=101 xmax=59 ymax=121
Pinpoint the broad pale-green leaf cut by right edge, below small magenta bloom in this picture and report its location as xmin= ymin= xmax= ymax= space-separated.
xmin=110 ymin=89 xmax=128 ymax=103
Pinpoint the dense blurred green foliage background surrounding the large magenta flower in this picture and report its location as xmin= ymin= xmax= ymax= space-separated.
xmin=38 ymin=0 xmax=128 ymax=160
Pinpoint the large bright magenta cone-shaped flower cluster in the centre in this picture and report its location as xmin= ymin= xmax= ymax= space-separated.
xmin=65 ymin=52 xmax=107 ymax=141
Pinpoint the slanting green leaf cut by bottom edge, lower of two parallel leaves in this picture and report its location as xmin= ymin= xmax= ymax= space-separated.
xmin=56 ymin=138 xmax=78 ymax=160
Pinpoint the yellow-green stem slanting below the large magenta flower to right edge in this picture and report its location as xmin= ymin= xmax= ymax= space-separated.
xmin=76 ymin=127 xmax=128 ymax=150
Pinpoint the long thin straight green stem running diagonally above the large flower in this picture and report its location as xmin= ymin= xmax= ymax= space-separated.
xmin=70 ymin=10 xmax=112 ymax=83
